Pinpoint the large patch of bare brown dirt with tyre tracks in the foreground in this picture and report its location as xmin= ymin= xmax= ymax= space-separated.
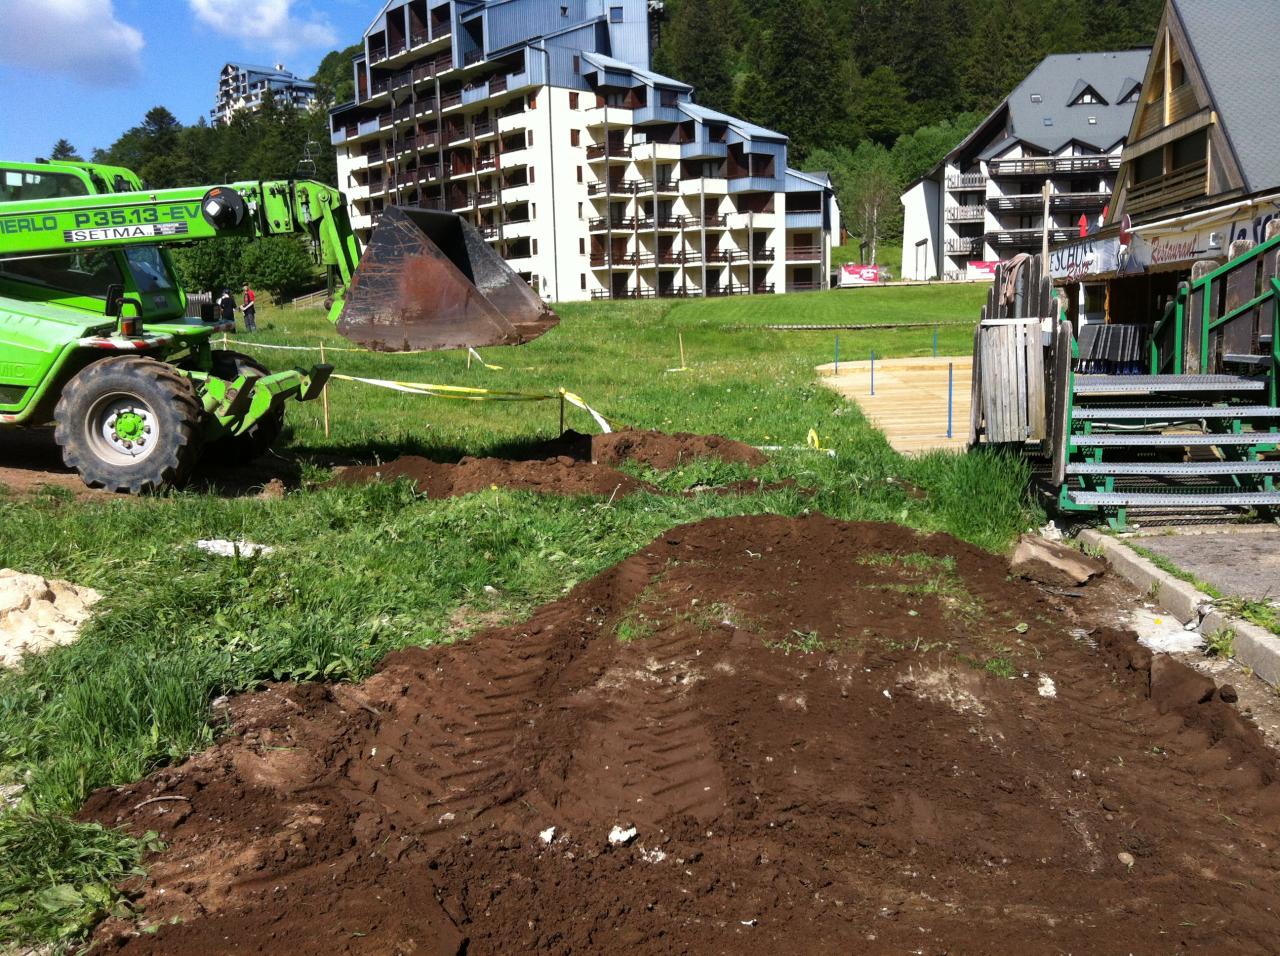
xmin=83 ymin=517 xmax=1280 ymax=956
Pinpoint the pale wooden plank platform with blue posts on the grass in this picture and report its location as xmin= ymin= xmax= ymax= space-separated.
xmin=818 ymin=356 xmax=973 ymax=454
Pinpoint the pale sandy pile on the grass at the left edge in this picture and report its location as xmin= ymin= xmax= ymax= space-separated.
xmin=0 ymin=570 xmax=101 ymax=667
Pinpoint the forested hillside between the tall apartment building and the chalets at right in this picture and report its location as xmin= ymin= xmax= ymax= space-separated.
xmin=654 ymin=0 xmax=1164 ymax=259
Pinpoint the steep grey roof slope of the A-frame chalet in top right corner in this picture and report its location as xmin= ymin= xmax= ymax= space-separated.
xmin=1170 ymin=0 xmax=1280 ymax=192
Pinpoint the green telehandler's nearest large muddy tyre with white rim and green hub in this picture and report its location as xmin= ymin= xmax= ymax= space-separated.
xmin=54 ymin=356 xmax=204 ymax=494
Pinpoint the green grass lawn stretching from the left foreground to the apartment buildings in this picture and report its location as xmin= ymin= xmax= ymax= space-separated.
xmin=0 ymin=285 xmax=1038 ymax=941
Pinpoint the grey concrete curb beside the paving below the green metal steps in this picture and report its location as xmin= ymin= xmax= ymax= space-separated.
xmin=1076 ymin=529 xmax=1280 ymax=687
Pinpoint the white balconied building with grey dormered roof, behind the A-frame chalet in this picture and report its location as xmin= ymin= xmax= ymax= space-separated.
xmin=902 ymin=49 xmax=1149 ymax=279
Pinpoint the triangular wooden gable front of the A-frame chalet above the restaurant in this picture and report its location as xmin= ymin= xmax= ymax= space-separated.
xmin=1107 ymin=0 xmax=1244 ymax=224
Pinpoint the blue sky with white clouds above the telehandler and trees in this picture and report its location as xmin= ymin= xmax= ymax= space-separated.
xmin=0 ymin=0 xmax=371 ymax=161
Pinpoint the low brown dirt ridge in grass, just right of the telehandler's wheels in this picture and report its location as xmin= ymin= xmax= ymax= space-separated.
xmin=333 ymin=456 xmax=648 ymax=498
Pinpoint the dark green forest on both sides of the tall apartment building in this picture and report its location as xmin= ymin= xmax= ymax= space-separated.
xmin=42 ymin=0 xmax=1164 ymax=285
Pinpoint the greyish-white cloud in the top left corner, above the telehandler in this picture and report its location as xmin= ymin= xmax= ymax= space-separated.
xmin=0 ymin=0 xmax=146 ymax=86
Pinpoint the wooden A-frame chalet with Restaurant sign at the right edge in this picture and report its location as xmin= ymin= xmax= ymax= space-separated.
xmin=1051 ymin=0 xmax=1280 ymax=325
